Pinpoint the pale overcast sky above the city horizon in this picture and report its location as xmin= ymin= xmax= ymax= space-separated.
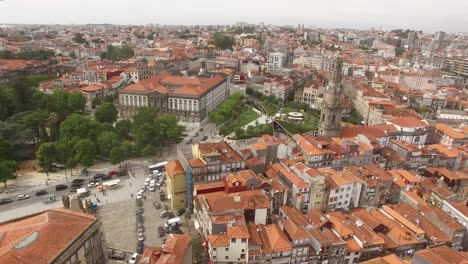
xmin=0 ymin=0 xmax=468 ymax=32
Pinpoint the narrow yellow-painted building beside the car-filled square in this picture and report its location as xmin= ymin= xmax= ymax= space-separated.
xmin=166 ymin=160 xmax=187 ymax=210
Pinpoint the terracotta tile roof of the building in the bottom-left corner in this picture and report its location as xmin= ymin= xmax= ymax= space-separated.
xmin=0 ymin=208 xmax=96 ymax=264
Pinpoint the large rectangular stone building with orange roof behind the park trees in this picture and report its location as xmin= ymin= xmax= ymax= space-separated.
xmin=119 ymin=72 xmax=228 ymax=123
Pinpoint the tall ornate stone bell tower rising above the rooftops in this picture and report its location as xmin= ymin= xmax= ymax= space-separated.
xmin=319 ymin=58 xmax=343 ymax=138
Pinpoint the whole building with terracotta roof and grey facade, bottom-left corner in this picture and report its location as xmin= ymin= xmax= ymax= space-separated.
xmin=0 ymin=208 xmax=108 ymax=264
